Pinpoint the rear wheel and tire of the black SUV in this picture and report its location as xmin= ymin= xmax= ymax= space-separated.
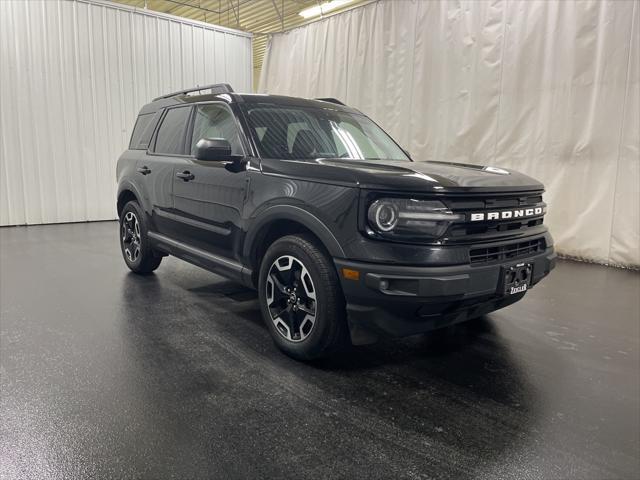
xmin=118 ymin=200 xmax=162 ymax=275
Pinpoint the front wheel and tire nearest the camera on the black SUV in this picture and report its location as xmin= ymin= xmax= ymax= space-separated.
xmin=258 ymin=235 xmax=349 ymax=361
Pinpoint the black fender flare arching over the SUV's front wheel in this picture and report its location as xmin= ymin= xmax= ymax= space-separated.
xmin=242 ymin=205 xmax=346 ymax=259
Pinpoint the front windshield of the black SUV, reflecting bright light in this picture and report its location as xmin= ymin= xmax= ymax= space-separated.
xmin=240 ymin=105 xmax=410 ymax=161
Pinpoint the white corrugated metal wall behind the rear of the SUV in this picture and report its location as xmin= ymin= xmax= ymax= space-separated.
xmin=0 ymin=0 xmax=252 ymax=225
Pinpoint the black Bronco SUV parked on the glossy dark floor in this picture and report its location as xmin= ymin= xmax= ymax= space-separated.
xmin=117 ymin=84 xmax=555 ymax=359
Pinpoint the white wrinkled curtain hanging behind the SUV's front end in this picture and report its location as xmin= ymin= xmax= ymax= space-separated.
xmin=260 ymin=0 xmax=640 ymax=266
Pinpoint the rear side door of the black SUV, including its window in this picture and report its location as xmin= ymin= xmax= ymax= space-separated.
xmin=143 ymin=105 xmax=192 ymax=237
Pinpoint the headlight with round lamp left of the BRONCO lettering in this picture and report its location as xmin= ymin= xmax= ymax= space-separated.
xmin=367 ymin=198 xmax=464 ymax=238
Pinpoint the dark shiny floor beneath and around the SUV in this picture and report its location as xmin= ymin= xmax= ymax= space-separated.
xmin=0 ymin=222 xmax=640 ymax=479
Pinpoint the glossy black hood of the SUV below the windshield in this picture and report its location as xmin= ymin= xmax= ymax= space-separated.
xmin=262 ymin=158 xmax=544 ymax=193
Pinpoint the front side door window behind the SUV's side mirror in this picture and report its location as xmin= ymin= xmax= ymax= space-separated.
xmin=191 ymin=105 xmax=244 ymax=155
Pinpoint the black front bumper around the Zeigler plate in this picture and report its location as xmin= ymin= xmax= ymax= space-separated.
xmin=334 ymin=247 xmax=556 ymax=345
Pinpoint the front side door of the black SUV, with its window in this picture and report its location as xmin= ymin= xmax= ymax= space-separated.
xmin=173 ymin=103 xmax=247 ymax=258
